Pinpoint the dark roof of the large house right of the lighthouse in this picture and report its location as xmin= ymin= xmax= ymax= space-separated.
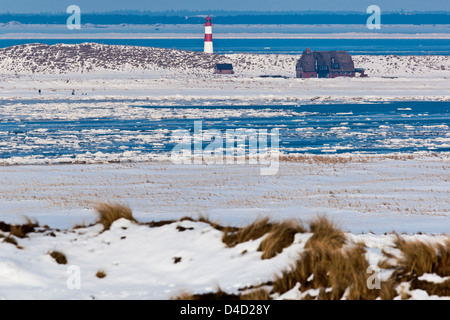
xmin=297 ymin=50 xmax=355 ymax=72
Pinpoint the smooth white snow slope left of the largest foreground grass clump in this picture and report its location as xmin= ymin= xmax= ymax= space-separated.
xmin=0 ymin=220 xmax=307 ymax=299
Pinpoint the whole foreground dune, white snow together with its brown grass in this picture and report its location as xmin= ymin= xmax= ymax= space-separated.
xmin=0 ymin=212 xmax=450 ymax=300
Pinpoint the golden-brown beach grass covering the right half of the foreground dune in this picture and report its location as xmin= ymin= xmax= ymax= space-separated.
xmin=171 ymin=212 xmax=450 ymax=300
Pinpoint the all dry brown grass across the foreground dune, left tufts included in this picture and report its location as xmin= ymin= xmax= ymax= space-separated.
xmin=0 ymin=203 xmax=450 ymax=300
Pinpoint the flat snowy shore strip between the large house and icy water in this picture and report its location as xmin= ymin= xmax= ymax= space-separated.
xmin=0 ymin=71 xmax=450 ymax=105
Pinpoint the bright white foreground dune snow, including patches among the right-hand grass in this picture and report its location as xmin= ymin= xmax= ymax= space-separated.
xmin=0 ymin=212 xmax=448 ymax=299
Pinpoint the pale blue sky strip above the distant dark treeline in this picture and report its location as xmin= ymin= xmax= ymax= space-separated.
xmin=0 ymin=0 xmax=450 ymax=13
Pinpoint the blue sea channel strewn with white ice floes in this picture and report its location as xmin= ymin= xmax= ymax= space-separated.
xmin=0 ymin=100 xmax=450 ymax=164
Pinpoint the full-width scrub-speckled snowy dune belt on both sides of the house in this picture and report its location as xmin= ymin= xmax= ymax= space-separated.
xmin=0 ymin=43 xmax=450 ymax=77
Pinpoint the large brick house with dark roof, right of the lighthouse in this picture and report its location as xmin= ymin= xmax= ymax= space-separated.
xmin=296 ymin=48 xmax=355 ymax=78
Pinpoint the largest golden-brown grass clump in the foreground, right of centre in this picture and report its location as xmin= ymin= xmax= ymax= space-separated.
xmin=273 ymin=217 xmax=395 ymax=300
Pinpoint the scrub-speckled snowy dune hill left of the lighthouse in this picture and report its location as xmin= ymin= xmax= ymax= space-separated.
xmin=0 ymin=43 xmax=225 ymax=74
